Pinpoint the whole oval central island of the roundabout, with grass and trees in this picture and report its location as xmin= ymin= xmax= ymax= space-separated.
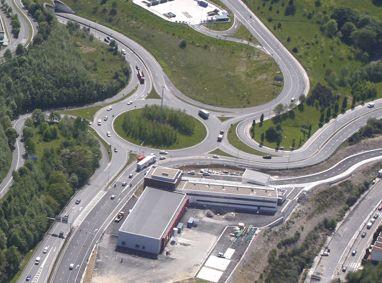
xmin=114 ymin=105 xmax=206 ymax=149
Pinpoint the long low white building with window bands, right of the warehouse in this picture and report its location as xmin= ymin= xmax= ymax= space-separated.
xmin=177 ymin=178 xmax=278 ymax=214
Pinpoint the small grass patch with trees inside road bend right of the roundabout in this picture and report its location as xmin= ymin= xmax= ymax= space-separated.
xmin=255 ymin=105 xmax=320 ymax=149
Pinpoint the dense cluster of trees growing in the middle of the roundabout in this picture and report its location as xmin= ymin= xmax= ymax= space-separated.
xmin=122 ymin=105 xmax=195 ymax=147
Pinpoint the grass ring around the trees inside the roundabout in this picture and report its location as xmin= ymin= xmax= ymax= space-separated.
xmin=114 ymin=109 xmax=207 ymax=149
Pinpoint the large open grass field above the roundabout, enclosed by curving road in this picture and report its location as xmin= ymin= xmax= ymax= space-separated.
xmin=62 ymin=0 xmax=281 ymax=107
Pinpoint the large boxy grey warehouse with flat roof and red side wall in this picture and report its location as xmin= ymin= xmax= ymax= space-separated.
xmin=117 ymin=187 xmax=188 ymax=257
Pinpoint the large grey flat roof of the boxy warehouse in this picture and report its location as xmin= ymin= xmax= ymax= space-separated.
xmin=119 ymin=187 xmax=186 ymax=239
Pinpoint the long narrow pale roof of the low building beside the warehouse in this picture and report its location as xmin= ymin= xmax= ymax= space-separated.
xmin=177 ymin=179 xmax=278 ymax=198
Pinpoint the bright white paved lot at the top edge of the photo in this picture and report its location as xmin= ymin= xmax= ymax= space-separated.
xmin=133 ymin=0 xmax=230 ymax=25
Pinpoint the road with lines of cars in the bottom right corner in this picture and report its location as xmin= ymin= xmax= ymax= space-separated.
xmin=315 ymin=181 xmax=382 ymax=282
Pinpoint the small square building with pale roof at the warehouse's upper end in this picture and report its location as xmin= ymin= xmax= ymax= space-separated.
xmin=143 ymin=166 xmax=183 ymax=190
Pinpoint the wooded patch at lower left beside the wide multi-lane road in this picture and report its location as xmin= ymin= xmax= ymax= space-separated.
xmin=0 ymin=111 xmax=101 ymax=282
